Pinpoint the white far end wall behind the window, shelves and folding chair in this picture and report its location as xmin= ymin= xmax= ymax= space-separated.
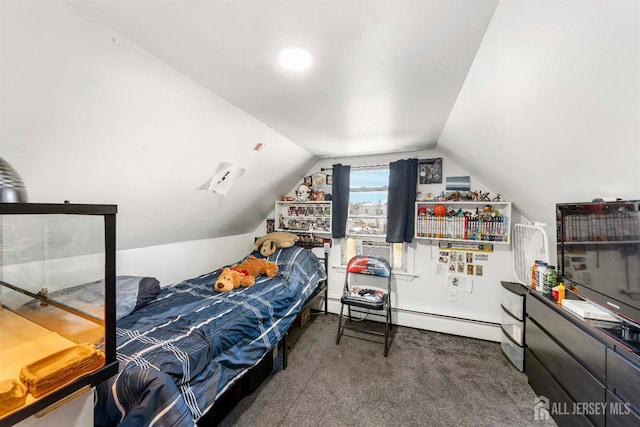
xmin=254 ymin=150 xmax=521 ymax=341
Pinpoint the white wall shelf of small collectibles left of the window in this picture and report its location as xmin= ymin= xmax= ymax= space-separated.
xmin=275 ymin=201 xmax=331 ymax=234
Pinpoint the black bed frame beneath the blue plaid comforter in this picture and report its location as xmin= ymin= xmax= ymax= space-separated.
xmin=197 ymin=251 xmax=329 ymax=427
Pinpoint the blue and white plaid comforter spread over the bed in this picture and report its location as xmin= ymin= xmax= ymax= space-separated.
xmin=95 ymin=246 xmax=326 ymax=427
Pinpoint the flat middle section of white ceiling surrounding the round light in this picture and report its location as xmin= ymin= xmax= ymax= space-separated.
xmin=65 ymin=0 xmax=497 ymax=157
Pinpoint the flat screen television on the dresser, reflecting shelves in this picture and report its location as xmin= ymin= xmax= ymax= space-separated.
xmin=556 ymin=200 xmax=640 ymax=326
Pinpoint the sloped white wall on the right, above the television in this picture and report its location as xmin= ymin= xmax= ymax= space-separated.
xmin=437 ymin=0 xmax=640 ymax=242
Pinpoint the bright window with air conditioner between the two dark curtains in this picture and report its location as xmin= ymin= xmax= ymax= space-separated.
xmin=342 ymin=166 xmax=407 ymax=271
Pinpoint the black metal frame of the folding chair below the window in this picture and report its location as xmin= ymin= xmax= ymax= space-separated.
xmin=336 ymin=255 xmax=393 ymax=357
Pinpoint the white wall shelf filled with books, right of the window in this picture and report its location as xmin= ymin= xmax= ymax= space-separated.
xmin=414 ymin=201 xmax=511 ymax=245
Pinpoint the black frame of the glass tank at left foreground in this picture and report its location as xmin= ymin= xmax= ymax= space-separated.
xmin=0 ymin=203 xmax=118 ymax=426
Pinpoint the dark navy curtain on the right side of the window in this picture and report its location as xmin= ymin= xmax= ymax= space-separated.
xmin=384 ymin=159 xmax=418 ymax=243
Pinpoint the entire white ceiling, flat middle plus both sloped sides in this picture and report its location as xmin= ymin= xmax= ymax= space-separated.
xmin=0 ymin=0 xmax=640 ymax=249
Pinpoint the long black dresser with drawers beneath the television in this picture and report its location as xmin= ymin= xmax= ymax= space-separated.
xmin=525 ymin=292 xmax=640 ymax=426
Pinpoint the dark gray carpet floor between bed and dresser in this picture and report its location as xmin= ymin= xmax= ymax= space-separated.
xmin=221 ymin=314 xmax=555 ymax=427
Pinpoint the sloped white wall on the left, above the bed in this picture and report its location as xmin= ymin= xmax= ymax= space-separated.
xmin=0 ymin=0 xmax=315 ymax=249
